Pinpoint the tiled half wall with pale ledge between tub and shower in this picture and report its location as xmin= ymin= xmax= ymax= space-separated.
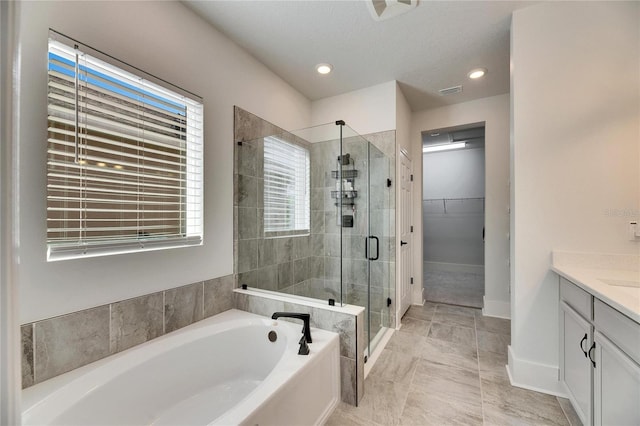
xmin=234 ymin=289 xmax=364 ymax=405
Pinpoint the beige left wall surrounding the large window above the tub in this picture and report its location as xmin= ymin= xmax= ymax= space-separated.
xmin=18 ymin=2 xmax=311 ymax=323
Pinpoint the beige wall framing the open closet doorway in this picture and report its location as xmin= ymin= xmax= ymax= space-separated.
xmin=411 ymin=95 xmax=509 ymax=317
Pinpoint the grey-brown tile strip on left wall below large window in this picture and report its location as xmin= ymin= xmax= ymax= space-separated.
xmin=21 ymin=275 xmax=235 ymax=388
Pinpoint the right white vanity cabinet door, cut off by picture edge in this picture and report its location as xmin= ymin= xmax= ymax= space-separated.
xmin=594 ymin=331 xmax=640 ymax=426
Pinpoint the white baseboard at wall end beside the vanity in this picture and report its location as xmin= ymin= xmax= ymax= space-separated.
xmin=507 ymin=345 xmax=567 ymax=398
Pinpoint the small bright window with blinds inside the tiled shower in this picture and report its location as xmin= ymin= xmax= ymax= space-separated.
xmin=264 ymin=137 xmax=310 ymax=236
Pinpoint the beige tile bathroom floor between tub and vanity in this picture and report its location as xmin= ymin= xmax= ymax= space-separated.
xmin=327 ymin=303 xmax=580 ymax=426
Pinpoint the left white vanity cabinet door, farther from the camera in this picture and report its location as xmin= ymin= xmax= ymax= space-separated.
xmin=560 ymin=302 xmax=592 ymax=425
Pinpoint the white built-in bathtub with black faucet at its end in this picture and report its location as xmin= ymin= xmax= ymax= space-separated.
xmin=22 ymin=310 xmax=340 ymax=425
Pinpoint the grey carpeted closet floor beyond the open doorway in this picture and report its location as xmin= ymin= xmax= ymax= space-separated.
xmin=424 ymin=269 xmax=484 ymax=308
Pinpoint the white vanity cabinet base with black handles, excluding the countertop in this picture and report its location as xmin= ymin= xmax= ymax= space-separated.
xmin=560 ymin=278 xmax=640 ymax=426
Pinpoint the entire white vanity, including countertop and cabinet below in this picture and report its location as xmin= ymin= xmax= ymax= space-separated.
xmin=552 ymin=252 xmax=640 ymax=426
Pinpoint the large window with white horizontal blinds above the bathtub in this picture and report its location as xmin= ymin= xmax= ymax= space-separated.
xmin=47 ymin=31 xmax=203 ymax=260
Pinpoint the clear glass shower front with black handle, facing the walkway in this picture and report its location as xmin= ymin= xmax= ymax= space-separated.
xmin=337 ymin=126 xmax=395 ymax=355
